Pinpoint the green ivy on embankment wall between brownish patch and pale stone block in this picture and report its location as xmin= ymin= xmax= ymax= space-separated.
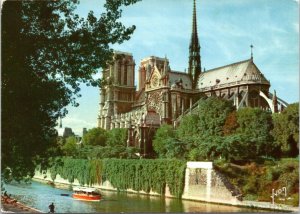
xmin=104 ymin=159 xmax=186 ymax=197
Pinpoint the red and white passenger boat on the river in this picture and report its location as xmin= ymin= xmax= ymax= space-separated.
xmin=72 ymin=187 xmax=101 ymax=201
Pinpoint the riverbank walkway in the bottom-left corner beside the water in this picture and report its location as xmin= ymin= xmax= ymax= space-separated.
xmin=1 ymin=196 xmax=42 ymax=213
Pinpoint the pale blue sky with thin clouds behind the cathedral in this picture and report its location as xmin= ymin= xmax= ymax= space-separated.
xmin=58 ymin=0 xmax=299 ymax=135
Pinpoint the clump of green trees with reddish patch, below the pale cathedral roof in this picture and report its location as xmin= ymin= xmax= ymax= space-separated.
xmin=173 ymin=97 xmax=284 ymax=161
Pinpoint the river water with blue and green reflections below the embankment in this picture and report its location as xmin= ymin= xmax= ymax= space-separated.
xmin=4 ymin=181 xmax=259 ymax=213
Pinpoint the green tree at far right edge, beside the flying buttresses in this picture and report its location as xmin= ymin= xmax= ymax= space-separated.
xmin=272 ymin=103 xmax=299 ymax=157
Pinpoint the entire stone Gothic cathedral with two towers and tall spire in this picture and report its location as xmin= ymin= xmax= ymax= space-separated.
xmin=98 ymin=0 xmax=287 ymax=155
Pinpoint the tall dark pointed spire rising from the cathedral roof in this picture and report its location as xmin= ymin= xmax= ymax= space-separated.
xmin=188 ymin=0 xmax=201 ymax=89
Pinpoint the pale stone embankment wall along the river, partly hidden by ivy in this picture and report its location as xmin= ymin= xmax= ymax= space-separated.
xmin=34 ymin=162 xmax=298 ymax=212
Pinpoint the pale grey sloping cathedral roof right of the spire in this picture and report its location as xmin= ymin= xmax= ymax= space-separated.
xmin=199 ymin=59 xmax=270 ymax=90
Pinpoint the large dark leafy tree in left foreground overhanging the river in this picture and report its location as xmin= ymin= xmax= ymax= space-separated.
xmin=1 ymin=0 xmax=137 ymax=180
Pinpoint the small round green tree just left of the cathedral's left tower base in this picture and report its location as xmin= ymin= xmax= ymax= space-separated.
xmin=83 ymin=128 xmax=108 ymax=146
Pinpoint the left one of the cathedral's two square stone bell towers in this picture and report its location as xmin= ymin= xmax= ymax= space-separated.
xmin=98 ymin=51 xmax=135 ymax=130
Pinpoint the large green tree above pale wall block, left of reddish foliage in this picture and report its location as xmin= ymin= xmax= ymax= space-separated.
xmin=177 ymin=97 xmax=235 ymax=160
